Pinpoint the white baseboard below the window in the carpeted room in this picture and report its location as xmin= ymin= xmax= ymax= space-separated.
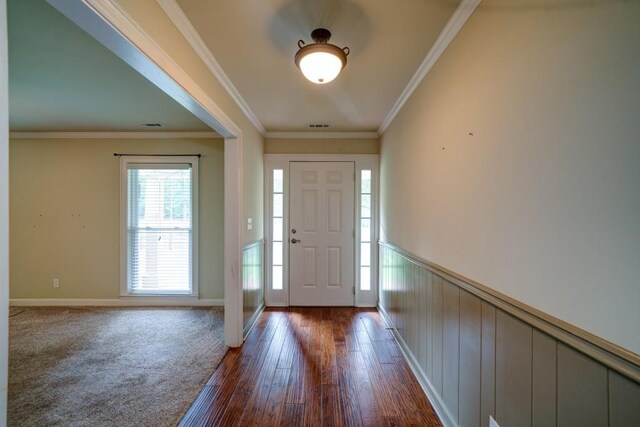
xmin=9 ymin=297 xmax=224 ymax=307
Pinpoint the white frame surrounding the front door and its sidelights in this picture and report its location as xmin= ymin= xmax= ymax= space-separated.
xmin=264 ymin=154 xmax=380 ymax=307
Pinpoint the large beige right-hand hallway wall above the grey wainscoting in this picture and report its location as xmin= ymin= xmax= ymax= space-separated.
xmin=381 ymin=1 xmax=640 ymax=353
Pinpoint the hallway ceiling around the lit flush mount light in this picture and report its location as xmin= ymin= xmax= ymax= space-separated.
xmin=177 ymin=0 xmax=460 ymax=132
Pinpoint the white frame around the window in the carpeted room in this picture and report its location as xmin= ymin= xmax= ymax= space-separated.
xmin=119 ymin=155 xmax=200 ymax=298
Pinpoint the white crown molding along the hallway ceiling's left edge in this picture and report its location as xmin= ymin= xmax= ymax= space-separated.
xmin=156 ymin=0 xmax=266 ymax=136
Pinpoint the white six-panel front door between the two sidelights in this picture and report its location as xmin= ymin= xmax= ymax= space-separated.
xmin=289 ymin=162 xmax=355 ymax=306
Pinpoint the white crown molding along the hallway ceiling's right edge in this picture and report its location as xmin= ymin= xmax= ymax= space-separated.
xmin=378 ymin=0 xmax=481 ymax=135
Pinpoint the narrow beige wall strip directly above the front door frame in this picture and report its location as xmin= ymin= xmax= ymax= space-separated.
xmin=264 ymin=138 xmax=380 ymax=154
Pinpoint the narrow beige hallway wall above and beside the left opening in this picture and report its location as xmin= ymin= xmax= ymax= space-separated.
xmin=116 ymin=0 xmax=264 ymax=244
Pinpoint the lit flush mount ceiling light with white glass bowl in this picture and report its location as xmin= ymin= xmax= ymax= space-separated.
xmin=295 ymin=28 xmax=350 ymax=84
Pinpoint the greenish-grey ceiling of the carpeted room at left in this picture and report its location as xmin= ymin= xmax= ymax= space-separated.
xmin=7 ymin=0 xmax=211 ymax=132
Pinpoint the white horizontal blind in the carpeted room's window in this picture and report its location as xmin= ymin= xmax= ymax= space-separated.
xmin=126 ymin=163 xmax=194 ymax=294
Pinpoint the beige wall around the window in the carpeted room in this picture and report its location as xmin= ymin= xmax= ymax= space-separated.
xmin=9 ymin=139 xmax=224 ymax=299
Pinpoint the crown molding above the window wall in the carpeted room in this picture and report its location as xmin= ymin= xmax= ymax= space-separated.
xmin=9 ymin=131 xmax=222 ymax=139
